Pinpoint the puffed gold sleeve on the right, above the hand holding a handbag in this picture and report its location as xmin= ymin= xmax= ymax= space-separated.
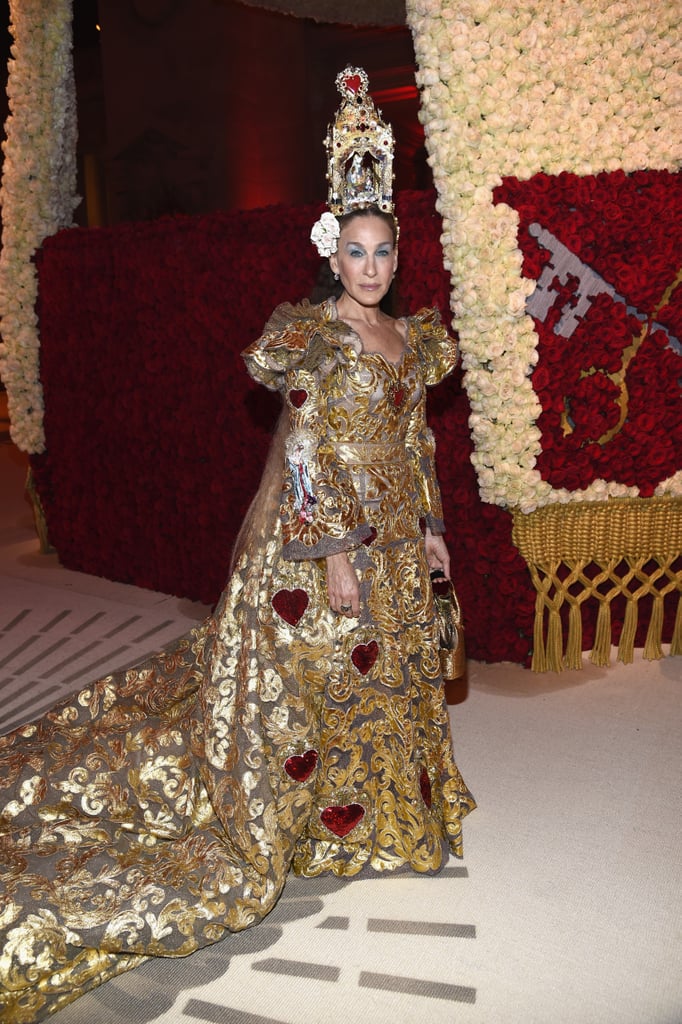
xmin=407 ymin=309 xmax=459 ymax=534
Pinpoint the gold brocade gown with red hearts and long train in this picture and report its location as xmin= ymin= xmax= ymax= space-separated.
xmin=0 ymin=300 xmax=475 ymax=1024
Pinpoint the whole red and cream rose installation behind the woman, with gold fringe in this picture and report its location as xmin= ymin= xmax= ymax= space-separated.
xmin=0 ymin=0 xmax=682 ymax=671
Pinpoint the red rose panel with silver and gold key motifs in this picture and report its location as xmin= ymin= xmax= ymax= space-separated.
xmin=495 ymin=171 xmax=682 ymax=498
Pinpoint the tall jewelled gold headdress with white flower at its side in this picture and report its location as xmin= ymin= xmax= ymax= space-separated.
xmin=310 ymin=67 xmax=393 ymax=256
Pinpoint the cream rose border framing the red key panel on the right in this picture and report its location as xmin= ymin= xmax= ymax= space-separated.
xmin=407 ymin=0 xmax=682 ymax=513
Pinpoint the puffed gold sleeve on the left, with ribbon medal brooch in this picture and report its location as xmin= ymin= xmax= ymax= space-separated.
xmin=242 ymin=303 xmax=372 ymax=560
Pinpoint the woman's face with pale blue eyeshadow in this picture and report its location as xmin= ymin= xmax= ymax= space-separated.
xmin=329 ymin=217 xmax=397 ymax=306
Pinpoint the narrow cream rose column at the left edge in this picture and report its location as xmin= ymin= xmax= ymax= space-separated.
xmin=0 ymin=0 xmax=79 ymax=453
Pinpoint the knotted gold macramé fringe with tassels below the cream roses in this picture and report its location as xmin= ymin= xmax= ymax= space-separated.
xmin=512 ymin=496 xmax=682 ymax=672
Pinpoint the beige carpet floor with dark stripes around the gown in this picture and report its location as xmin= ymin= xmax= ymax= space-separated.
xmin=0 ymin=409 xmax=682 ymax=1024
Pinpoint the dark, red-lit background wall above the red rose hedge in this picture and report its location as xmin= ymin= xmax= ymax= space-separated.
xmin=0 ymin=0 xmax=431 ymax=225
